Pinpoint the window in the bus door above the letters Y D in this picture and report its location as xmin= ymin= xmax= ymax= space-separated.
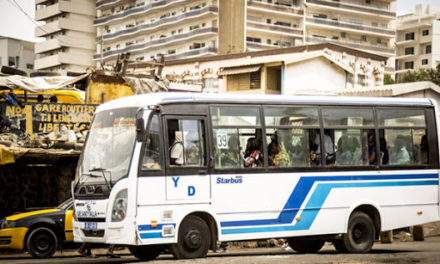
xmin=167 ymin=119 xmax=206 ymax=167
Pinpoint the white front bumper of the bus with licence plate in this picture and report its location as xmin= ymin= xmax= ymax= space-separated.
xmin=73 ymin=218 xmax=136 ymax=245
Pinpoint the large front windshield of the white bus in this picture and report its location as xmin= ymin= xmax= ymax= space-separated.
xmin=76 ymin=108 xmax=137 ymax=185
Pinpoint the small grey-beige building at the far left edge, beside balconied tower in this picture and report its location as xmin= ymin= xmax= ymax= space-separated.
xmin=0 ymin=36 xmax=35 ymax=73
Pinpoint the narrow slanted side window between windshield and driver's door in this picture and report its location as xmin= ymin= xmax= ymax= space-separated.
xmin=141 ymin=114 xmax=161 ymax=170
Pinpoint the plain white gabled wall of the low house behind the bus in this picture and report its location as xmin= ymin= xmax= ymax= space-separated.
xmin=283 ymin=57 xmax=346 ymax=95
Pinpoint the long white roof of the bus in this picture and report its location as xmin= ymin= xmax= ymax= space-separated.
xmin=96 ymin=92 xmax=432 ymax=112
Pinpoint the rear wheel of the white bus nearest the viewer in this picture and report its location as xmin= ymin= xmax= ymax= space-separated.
xmin=338 ymin=211 xmax=376 ymax=253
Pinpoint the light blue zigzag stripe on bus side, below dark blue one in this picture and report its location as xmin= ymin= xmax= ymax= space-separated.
xmin=222 ymin=179 xmax=439 ymax=235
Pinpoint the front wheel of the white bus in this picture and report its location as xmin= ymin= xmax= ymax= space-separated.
xmin=170 ymin=215 xmax=211 ymax=259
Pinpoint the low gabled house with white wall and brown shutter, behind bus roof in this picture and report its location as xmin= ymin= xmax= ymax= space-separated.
xmin=153 ymin=43 xmax=387 ymax=95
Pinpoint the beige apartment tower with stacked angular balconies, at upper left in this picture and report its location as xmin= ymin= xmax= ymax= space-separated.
xmin=35 ymin=0 xmax=96 ymax=74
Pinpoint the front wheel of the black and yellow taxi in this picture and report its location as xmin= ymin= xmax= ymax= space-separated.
xmin=26 ymin=227 xmax=58 ymax=258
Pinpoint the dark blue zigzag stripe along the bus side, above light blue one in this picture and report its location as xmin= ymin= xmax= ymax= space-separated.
xmin=220 ymin=174 xmax=438 ymax=227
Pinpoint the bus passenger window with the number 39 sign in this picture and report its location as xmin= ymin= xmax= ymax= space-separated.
xmin=211 ymin=106 xmax=264 ymax=169
